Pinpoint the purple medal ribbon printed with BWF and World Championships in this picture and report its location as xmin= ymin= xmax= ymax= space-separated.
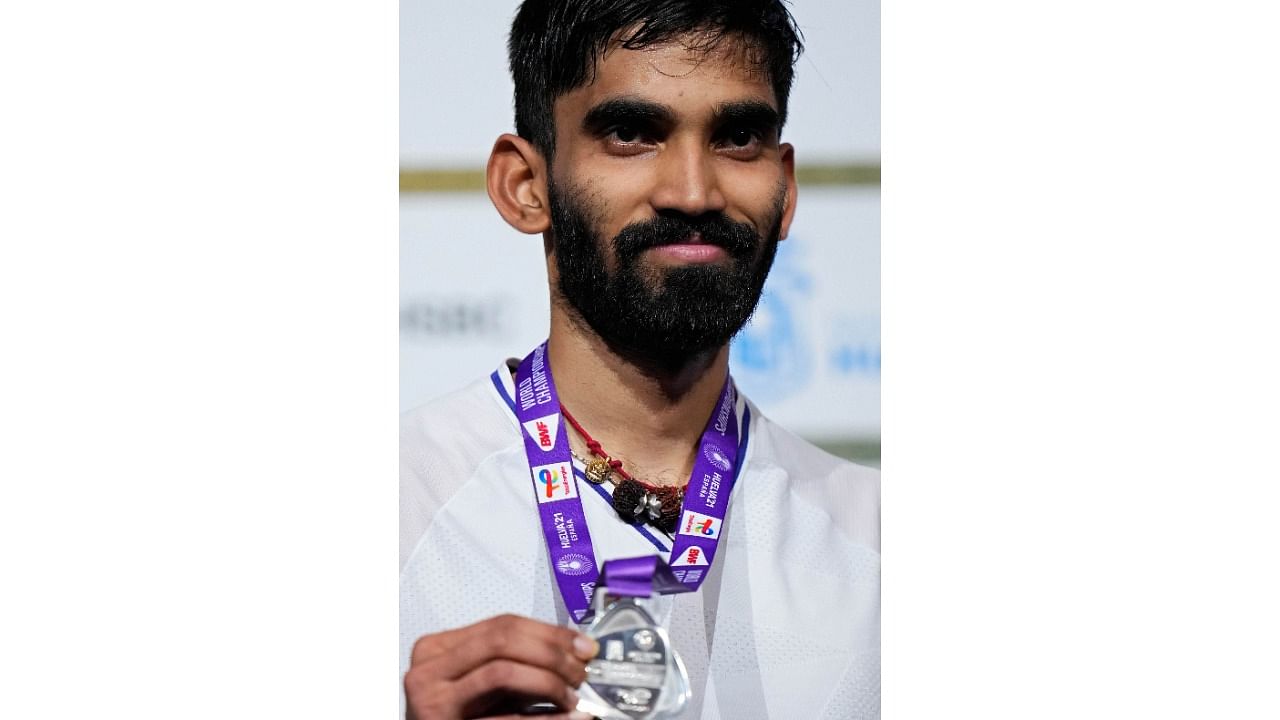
xmin=516 ymin=342 xmax=739 ymax=623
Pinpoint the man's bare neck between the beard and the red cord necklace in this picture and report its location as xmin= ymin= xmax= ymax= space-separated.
xmin=547 ymin=313 xmax=728 ymax=486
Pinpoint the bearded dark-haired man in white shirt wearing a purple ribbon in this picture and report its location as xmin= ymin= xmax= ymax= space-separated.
xmin=401 ymin=0 xmax=879 ymax=719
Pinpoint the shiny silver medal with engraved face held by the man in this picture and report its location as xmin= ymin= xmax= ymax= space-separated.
xmin=577 ymin=600 xmax=691 ymax=720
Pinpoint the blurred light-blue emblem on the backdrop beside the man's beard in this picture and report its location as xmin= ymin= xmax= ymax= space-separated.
xmin=730 ymin=241 xmax=814 ymax=404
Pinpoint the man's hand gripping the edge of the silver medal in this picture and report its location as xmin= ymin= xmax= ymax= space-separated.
xmin=404 ymin=615 xmax=596 ymax=720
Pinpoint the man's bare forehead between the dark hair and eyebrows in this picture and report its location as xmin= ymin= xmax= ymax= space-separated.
xmin=558 ymin=35 xmax=777 ymax=111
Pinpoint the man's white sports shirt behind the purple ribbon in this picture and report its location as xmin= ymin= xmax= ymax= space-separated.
xmin=399 ymin=365 xmax=879 ymax=720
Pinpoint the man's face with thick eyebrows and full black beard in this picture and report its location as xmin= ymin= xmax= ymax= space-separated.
xmin=549 ymin=32 xmax=795 ymax=363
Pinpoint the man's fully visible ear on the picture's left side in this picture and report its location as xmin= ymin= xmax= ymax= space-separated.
xmin=485 ymin=133 xmax=552 ymax=234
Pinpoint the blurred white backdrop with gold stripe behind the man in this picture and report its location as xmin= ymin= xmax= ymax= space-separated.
xmin=399 ymin=0 xmax=881 ymax=464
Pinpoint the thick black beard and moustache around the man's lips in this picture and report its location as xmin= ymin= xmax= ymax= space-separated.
xmin=549 ymin=176 xmax=786 ymax=369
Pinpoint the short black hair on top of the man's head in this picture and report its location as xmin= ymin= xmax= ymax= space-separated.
xmin=507 ymin=0 xmax=804 ymax=160
